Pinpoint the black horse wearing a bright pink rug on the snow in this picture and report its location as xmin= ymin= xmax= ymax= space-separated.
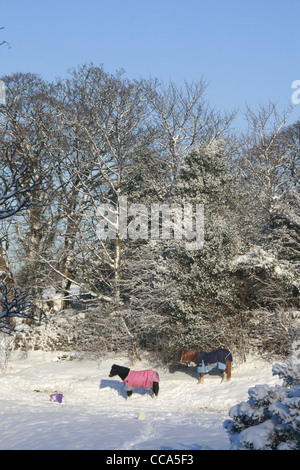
xmin=109 ymin=364 xmax=159 ymax=398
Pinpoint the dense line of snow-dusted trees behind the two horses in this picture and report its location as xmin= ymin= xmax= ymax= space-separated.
xmin=0 ymin=65 xmax=300 ymax=359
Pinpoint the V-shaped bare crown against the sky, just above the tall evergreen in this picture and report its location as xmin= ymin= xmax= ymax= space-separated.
xmin=150 ymin=79 xmax=234 ymax=186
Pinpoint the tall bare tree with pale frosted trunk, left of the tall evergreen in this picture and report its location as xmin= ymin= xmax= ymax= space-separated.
xmin=63 ymin=66 xmax=151 ymax=310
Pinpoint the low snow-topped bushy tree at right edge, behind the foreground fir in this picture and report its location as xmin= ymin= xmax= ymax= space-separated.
xmin=230 ymin=246 xmax=299 ymax=355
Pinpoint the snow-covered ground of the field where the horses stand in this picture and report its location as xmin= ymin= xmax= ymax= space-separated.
xmin=0 ymin=351 xmax=281 ymax=450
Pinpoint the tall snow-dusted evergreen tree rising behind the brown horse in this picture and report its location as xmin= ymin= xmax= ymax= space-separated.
xmin=173 ymin=139 xmax=241 ymax=349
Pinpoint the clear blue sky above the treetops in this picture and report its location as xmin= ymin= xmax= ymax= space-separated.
xmin=0 ymin=0 xmax=300 ymax=126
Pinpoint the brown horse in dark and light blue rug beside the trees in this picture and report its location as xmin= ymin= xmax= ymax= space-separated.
xmin=180 ymin=348 xmax=233 ymax=384
